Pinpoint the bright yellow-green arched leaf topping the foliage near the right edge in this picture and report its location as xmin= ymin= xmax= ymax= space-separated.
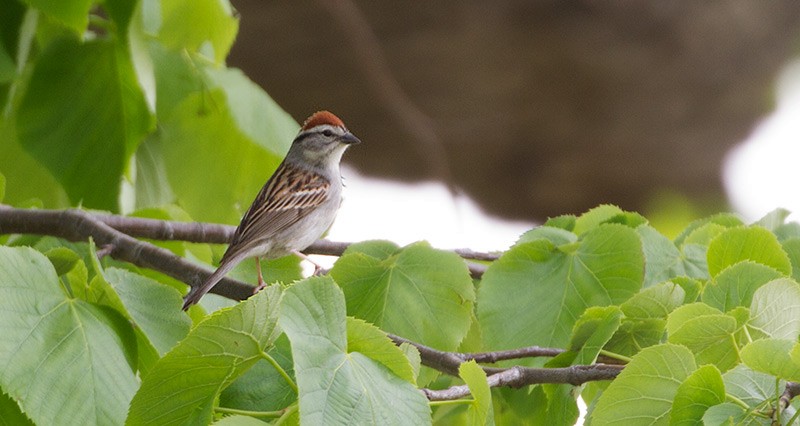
xmin=707 ymin=226 xmax=792 ymax=277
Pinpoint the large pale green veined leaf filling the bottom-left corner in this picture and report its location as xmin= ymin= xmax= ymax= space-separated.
xmin=0 ymin=247 xmax=138 ymax=424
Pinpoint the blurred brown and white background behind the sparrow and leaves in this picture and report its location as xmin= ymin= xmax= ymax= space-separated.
xmin=223 ymin=0 xmax=800 ymax=248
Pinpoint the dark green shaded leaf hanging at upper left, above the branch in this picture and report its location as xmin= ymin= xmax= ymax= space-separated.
xmin=16 ymin=38 xmax=151 ymax=211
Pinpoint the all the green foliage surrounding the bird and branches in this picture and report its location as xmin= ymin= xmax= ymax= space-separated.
xmin=0 ymin=0 xmax=800 ymax=425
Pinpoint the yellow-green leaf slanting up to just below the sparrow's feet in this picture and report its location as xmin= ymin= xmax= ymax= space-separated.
xmin=126 ymin=285 xmax=281 ymax=425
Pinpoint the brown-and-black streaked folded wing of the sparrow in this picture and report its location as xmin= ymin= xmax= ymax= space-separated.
xmin=222 ymin=163 xmax=331 ymax=262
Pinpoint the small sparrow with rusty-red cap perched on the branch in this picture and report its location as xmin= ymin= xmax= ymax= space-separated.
xmin=183 ymin=111 xmax=360 ymax=310
